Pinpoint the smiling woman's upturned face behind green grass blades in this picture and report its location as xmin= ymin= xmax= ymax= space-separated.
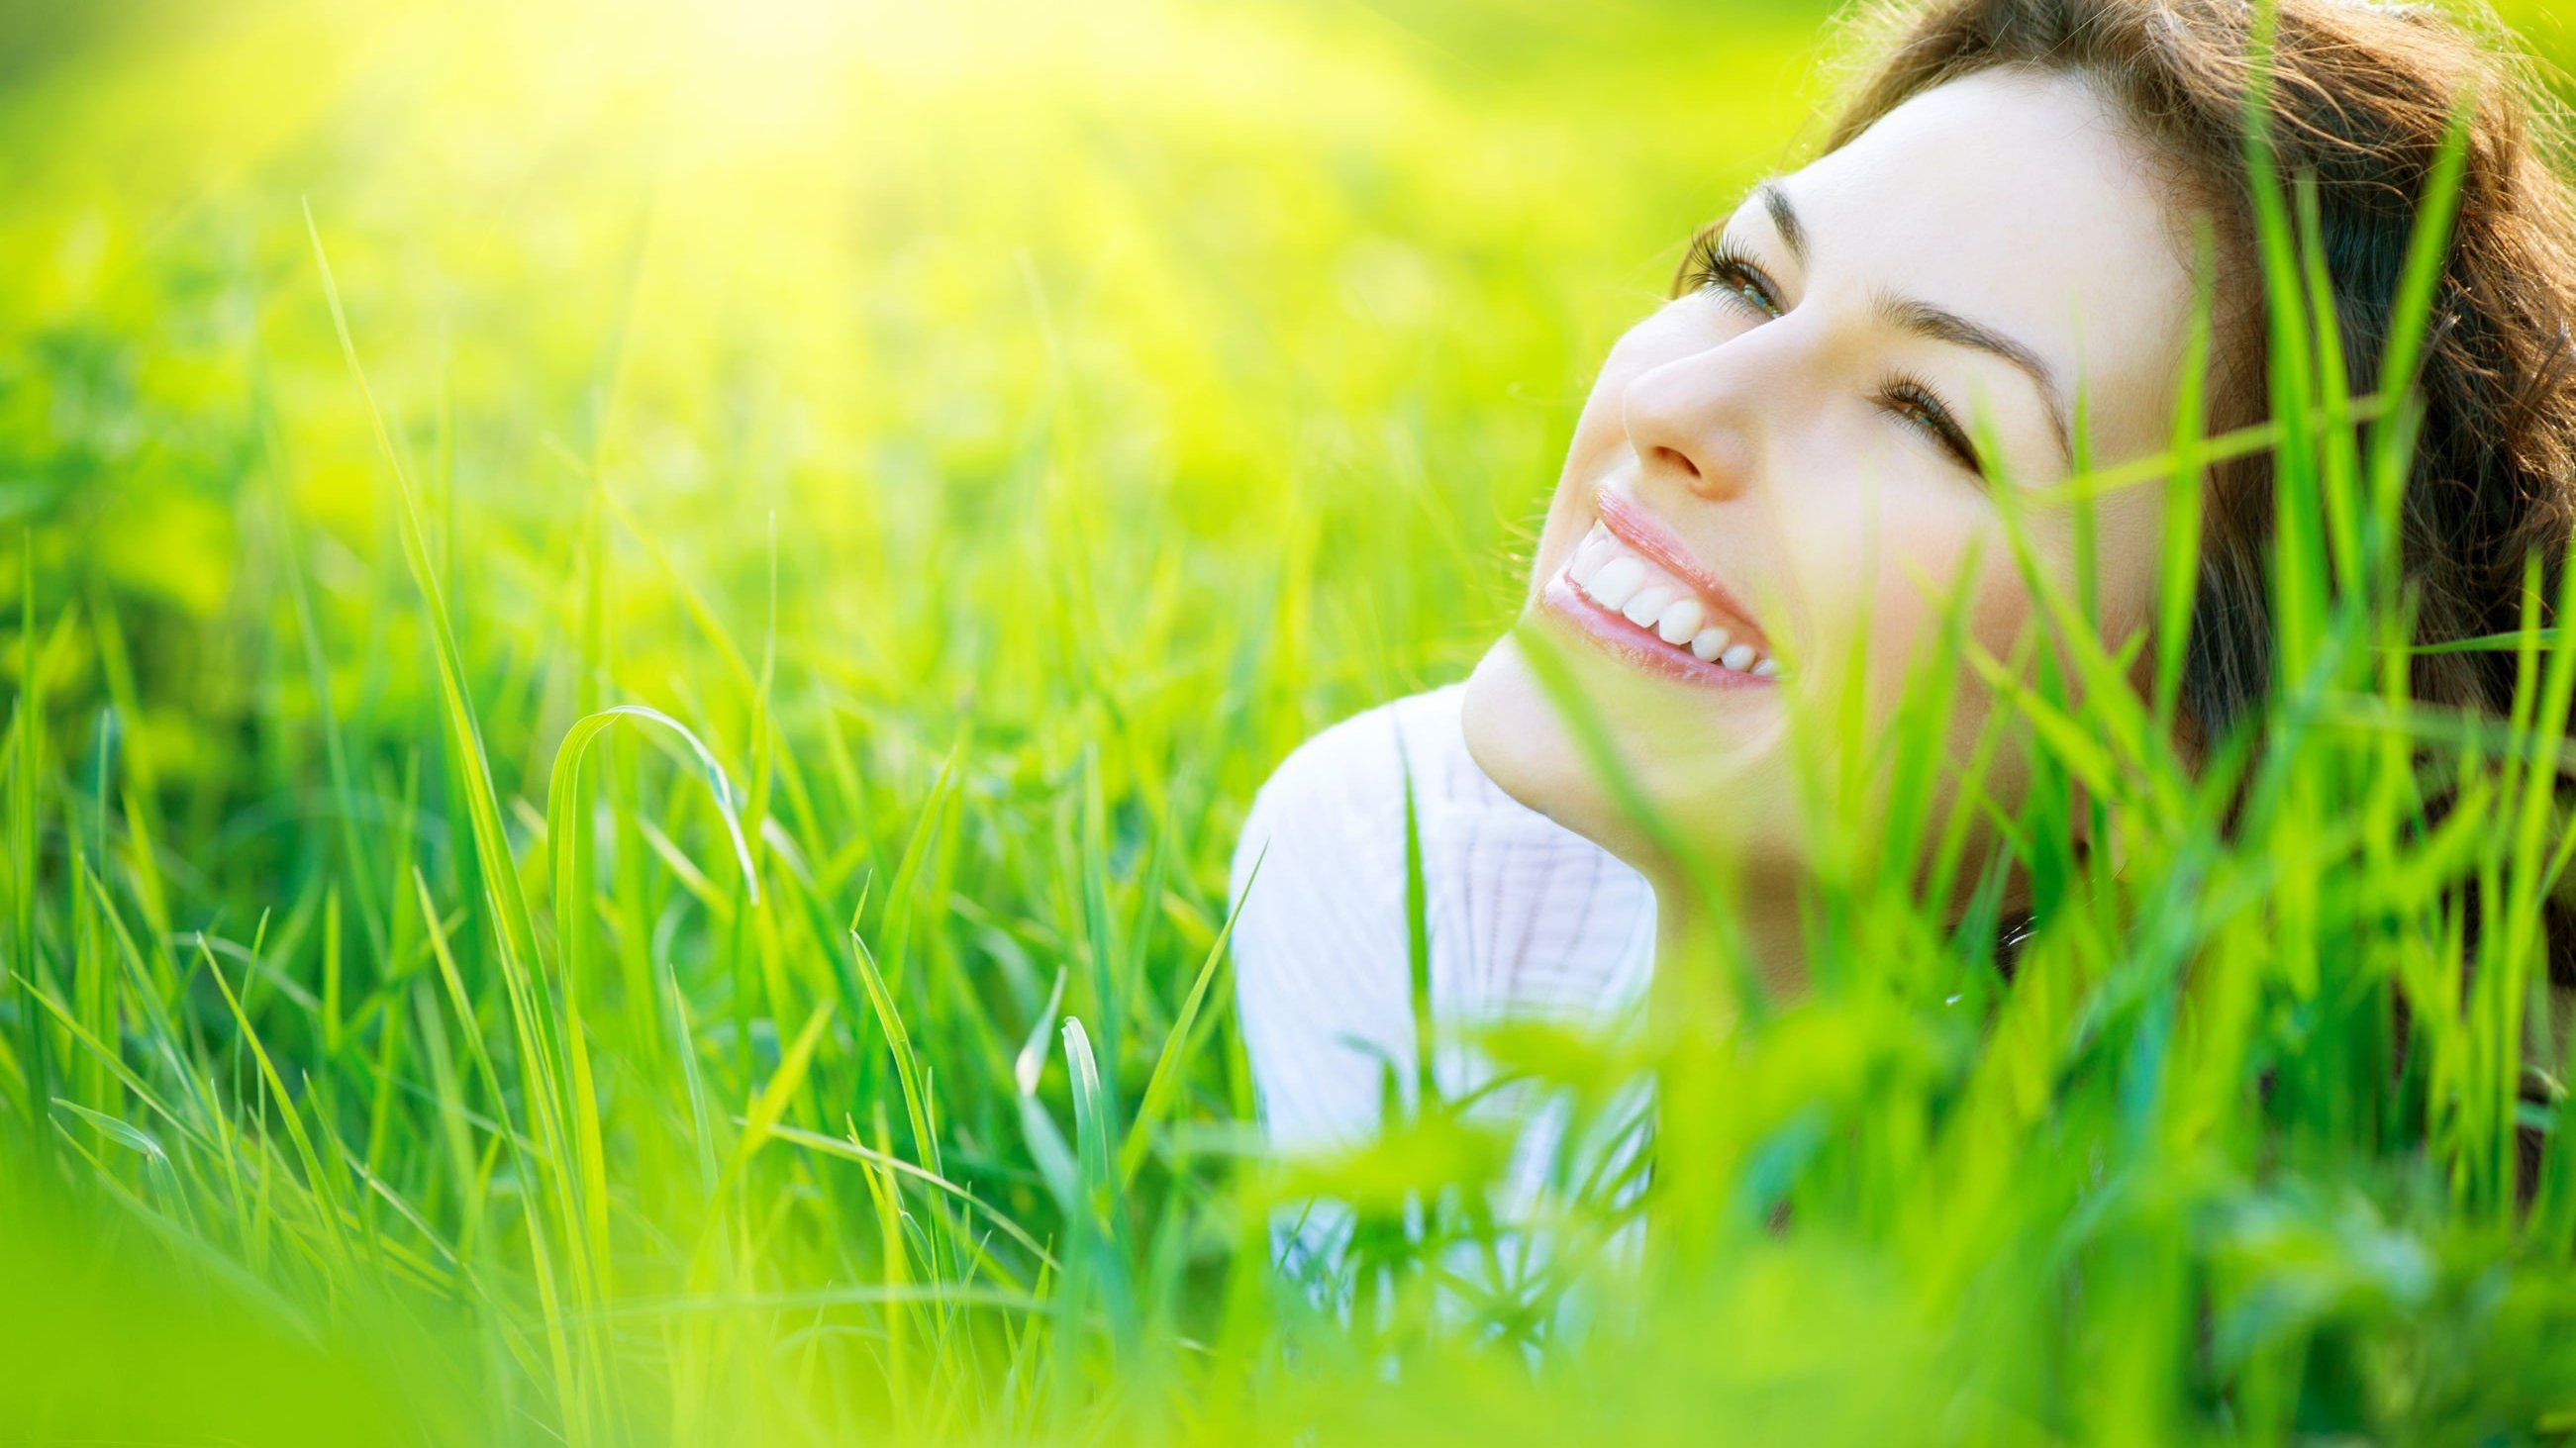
xmin=1466 ymin=69 xmax=2192 ymax=873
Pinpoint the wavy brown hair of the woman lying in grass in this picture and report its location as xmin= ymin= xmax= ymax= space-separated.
xmin=1827 ymin=0 xmax=2576 ymax=744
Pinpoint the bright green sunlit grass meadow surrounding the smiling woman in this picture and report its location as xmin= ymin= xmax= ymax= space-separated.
xmin=15 ymin=0 xmax=2576 ymax=1443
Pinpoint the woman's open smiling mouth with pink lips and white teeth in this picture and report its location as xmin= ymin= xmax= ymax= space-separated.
xmin=1545 ymin=497 xmax=1783 ymax=685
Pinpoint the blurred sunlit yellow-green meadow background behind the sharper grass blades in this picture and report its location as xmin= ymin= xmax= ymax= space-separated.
xmin=0 ymin=0 xmax=1822 ymax=814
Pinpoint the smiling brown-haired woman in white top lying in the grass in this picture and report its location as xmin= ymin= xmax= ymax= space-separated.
xmin=1234 ymin=0 xmax=2576 ymax=1252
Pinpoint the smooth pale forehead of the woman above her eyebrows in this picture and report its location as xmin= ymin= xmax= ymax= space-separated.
xmin=1780 ymin=69 xmax=2192 ymax=433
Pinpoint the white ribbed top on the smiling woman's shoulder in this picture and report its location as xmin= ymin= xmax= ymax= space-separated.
xmin=1232 ymin=685 xmax=1653 ymax=1267
